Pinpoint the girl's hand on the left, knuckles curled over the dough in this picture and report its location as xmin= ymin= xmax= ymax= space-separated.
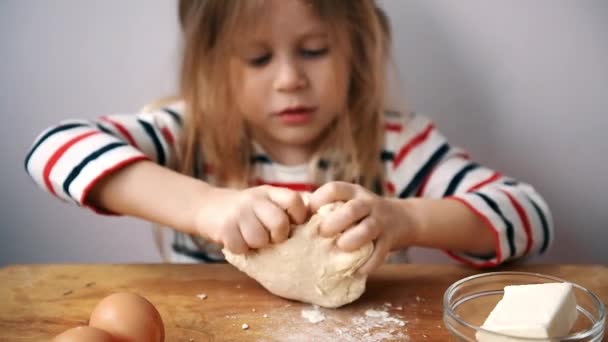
xmin=195 ymin=185 xmax=308 ymax=254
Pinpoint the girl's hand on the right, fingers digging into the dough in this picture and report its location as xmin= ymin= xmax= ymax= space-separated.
xmin=309 ymin=182 xmax=412 ymax=274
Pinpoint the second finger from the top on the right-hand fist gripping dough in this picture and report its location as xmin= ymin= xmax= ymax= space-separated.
xmin=319 ymin=199 xmax=371 ymax=237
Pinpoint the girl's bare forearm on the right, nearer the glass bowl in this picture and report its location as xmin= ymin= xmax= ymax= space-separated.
xmin=391 ymin=198 xmax=495 ymax=255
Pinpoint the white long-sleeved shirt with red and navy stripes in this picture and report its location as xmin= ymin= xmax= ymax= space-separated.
xmin=25 ymin=102 xmax=553 ymax=267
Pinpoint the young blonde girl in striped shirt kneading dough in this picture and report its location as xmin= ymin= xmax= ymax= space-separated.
xmin=25 ymin=0 xmax=553 ymax=273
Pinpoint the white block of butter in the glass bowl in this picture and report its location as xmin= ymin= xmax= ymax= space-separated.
xmin=475 ymin=283 xmax=577 ymax=342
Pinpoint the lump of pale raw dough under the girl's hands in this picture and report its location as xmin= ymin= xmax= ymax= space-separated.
xmin=222 ymin=202 xmax=374 ymax=308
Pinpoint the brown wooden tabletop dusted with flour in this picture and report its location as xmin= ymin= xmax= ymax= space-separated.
xmin=0 ymin=264 xmax=608 ymax=342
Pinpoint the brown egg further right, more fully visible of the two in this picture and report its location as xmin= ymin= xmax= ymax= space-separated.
xmin=89 ymin=292 xmax=165 ymax=342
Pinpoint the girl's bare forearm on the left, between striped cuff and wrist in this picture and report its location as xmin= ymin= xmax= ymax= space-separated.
xmin=86 ymin=161 xmax=212 ymax=233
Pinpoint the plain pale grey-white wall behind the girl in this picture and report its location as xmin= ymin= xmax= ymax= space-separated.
xmin=0 ymin=0 xmax=608 ymax=265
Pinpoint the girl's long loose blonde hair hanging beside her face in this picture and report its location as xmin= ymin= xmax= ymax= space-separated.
xmin=178 ymin=0 xmax=390 ymax=189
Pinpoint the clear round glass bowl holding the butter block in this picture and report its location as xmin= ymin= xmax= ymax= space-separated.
xmin=443 ymin=272 xmax=606 ymax=342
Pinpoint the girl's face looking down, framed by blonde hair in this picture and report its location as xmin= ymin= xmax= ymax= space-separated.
xmin=231 ymin=0 xmax=348 ymax=160
